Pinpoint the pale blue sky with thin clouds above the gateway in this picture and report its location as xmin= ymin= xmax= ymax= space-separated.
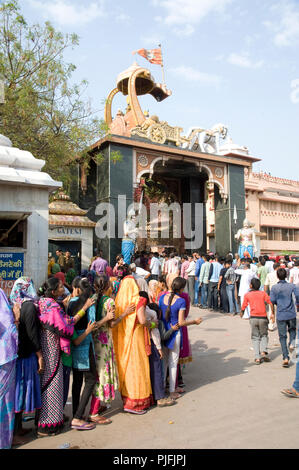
xmin=20 ymin=0 xmax=299 ymax=180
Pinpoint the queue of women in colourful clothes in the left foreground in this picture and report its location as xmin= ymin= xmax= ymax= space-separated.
xmin=0 ymin=252 xmax=202 ymax=448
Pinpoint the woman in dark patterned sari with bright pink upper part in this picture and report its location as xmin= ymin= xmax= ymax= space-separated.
xmin=37 ymin=278 xmax=90 ymax=437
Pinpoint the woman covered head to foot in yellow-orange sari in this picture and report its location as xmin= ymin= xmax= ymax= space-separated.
xmin=113 ymin=276 xmax=154 ymax=414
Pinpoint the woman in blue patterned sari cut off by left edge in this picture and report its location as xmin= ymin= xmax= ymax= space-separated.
xmin=0 ymin=289 xmax=18 ymax=449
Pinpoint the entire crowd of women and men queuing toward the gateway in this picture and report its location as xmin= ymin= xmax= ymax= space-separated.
xmin=0 ymin=251 xmax=299 ymax=448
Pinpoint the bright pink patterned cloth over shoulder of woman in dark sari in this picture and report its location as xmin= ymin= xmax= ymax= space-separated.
xmin=39 ymin=297 xmax=75 ymax=354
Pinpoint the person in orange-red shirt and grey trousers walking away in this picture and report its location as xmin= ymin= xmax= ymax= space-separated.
xmin=240 ymin=278 xmax=275 ymax=364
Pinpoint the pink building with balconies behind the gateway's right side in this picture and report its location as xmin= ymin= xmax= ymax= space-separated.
xmin=245 ymin=171 xmax=299 ymax=255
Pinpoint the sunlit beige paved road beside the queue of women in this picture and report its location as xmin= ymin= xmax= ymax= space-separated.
xmin=21 ymin=308 xmax=299 ymax=449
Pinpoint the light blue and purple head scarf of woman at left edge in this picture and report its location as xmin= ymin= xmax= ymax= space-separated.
xmin=0 ymin=289 xmax=18 ymax=366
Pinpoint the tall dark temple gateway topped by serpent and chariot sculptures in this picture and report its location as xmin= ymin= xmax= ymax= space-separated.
xmin=72 ymin=63 xmax=259 ymax=262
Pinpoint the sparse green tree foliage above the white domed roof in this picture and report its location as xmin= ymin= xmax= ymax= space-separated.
xmin=0 ymin=0 xmax=107 ymax=189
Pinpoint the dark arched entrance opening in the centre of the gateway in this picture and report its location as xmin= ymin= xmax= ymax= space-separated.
xmin=137 ymin=156 xmax=212 ymax=253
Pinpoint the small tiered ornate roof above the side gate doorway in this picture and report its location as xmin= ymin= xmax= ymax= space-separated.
xmin=49 ymin=190 xmax=96 ymax=227
